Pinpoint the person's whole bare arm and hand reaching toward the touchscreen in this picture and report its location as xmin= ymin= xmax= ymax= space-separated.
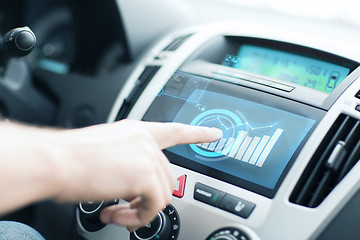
xmin=0 ymin=120 xmax=222 ymax=229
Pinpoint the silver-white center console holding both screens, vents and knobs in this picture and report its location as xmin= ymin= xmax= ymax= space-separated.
xmin=77 ymin=23 xmax=360 ymax=240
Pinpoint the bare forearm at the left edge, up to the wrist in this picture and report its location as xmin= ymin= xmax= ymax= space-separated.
xmin=0 ymin=122 xmax=60 ymax=214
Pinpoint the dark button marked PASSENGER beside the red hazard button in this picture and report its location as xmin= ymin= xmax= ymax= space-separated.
xmin=194 ymin=183 xmax=225 ymax=207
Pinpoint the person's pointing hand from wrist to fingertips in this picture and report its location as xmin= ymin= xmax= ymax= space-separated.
xmin=54 ymin=120 xmax=222 ymax=231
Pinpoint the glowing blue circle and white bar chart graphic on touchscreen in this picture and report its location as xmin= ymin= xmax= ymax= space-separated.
xmin=190 ymin=109 xmax=284 ymax=167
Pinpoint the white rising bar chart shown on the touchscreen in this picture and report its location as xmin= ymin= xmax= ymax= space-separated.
xmin=196 ymin=128 xmax=284 ymax=167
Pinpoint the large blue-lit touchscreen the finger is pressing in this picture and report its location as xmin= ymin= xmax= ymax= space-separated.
xmin=143 ymin=72 xmax=315 ymax=195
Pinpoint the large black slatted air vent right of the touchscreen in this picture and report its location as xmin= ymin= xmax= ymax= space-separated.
xmin=290 ymin=114 xmax=360 ymax=208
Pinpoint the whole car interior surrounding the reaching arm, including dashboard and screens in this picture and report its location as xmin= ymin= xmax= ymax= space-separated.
xmin=0 ymin=0 xmax=360 ymax=240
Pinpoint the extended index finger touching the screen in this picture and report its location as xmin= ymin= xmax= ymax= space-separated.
xmin=144 ymin=122 xmax=223 ymax=149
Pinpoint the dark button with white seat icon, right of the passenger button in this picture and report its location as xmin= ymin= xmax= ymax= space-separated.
xmin=219 ymin=194 xmax=255 ymax=218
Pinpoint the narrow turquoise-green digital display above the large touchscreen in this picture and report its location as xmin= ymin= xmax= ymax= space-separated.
xmin=228 ymin=44 xmax=350 ymax=93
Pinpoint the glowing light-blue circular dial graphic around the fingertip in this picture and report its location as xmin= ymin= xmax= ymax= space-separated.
xmin=190 ymin=109 xmax=245 ymax=158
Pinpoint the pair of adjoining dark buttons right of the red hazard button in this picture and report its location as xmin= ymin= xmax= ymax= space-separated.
xmin=194 ymin=183 xmax=255 ymax=218
